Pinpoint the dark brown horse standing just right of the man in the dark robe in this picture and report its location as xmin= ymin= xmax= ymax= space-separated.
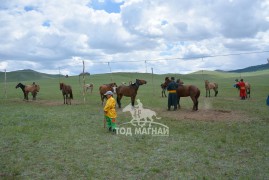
xmin=165 ymin=78 xmax=200 ymax=111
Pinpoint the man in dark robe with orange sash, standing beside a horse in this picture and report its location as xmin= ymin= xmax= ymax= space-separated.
xmin=167 ymin=77 xmax=178 ymax=111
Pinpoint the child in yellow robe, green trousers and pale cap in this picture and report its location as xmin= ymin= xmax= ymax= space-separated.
xmin=104 ymin=91 xmax=117 ymax=132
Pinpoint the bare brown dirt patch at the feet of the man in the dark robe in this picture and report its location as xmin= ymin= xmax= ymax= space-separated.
xmin=156 ymin=109 xmax=250 ymax=121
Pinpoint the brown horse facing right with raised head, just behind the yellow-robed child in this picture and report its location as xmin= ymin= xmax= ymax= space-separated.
xmin=116 ymin=79 xmax=147 ymax=108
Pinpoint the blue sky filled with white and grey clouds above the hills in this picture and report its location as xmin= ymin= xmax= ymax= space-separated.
xmin=0 ymin=0 xmax=269 ymax=75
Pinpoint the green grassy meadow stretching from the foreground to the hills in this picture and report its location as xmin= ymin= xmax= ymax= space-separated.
xmin=0 ymin=70 xmax=269 ymax=179
